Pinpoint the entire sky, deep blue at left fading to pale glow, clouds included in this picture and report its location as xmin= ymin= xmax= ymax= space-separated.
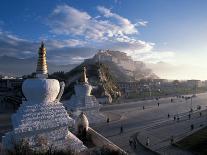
xmin=0 ymin=0 xmax=207 ymax=80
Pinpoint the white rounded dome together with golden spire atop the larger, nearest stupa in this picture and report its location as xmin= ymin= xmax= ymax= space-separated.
xmin=22 ymin=42 xmax=60 ymax=104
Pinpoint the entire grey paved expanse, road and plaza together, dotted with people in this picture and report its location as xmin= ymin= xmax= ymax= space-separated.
xmin=93 ymin=93 xmax=207 ymax=155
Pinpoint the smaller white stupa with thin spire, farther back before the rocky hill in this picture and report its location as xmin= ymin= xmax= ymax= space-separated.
xmin=64 ymin=67 xmax=105 ymax=124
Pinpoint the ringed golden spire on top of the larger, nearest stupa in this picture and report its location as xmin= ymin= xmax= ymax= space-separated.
xmin=36 ymin=42 xmax=48 ymax=78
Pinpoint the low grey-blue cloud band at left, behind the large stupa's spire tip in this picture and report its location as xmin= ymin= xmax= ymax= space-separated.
xmin=0 ymin=31 xmax=96 ymax=64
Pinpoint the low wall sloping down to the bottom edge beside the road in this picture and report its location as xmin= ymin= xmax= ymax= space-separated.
xmin=88 ymin=127 xmax=127 ymax=155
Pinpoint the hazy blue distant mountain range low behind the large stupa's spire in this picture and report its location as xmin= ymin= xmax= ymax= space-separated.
xmin=0 ymin=56 xmax=77 ymax=76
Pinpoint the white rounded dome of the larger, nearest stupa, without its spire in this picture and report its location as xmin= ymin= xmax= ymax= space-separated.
xmin=22 ymin=78 xmax=60 ymax=103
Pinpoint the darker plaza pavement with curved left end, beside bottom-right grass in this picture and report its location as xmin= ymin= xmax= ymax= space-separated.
xmin=136 ymin=110 xmax=207 ymax=155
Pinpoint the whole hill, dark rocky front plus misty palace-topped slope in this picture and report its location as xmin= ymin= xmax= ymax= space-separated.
xmin=50 ymin=51 xmax=158 ymax=100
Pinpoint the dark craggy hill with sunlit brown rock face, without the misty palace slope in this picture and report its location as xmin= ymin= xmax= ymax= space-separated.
xmin=49 ymin=62 xmax=121 ymax=103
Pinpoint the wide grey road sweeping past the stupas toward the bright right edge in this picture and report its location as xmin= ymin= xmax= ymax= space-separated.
xmin=93 ymin=93 xmax=207 ymax=154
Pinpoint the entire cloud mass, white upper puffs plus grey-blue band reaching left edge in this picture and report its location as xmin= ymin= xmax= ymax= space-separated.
xmin=0 ymin=5 xmax=175 ymax=64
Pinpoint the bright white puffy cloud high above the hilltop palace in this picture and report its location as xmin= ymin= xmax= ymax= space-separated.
xmin=48 ymin=5 xmax=162 ymax=61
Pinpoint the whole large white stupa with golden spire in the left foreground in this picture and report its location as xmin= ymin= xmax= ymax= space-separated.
xmin=2 ymin=43 xmax=86 ymax=152
